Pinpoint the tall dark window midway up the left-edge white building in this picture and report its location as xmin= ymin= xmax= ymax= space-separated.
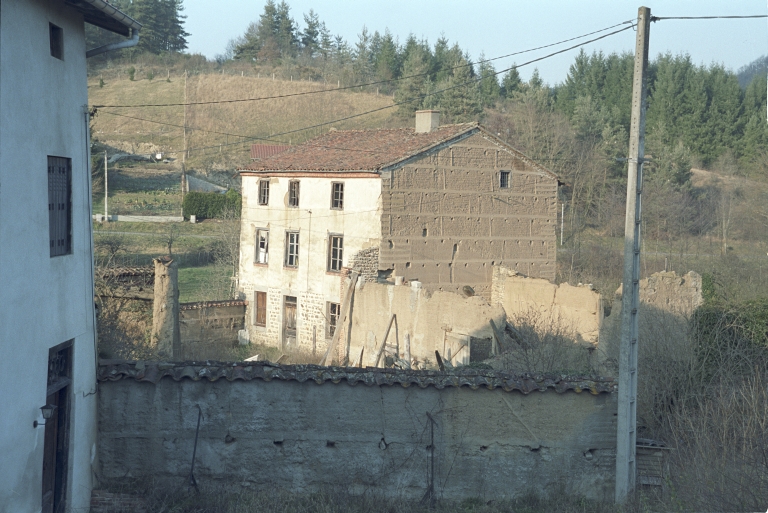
xmin=48 ymin=157 xmax=72 ymax=257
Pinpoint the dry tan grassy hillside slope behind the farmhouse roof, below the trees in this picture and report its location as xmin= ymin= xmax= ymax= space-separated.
xmin=88 ymin=74 xmax=405 ymax=172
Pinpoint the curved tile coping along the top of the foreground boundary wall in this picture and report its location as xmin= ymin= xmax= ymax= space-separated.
xmin=97 ymin=360 xmax=617 ymax=395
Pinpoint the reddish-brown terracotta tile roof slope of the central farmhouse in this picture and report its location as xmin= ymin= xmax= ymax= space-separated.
xmin=241 ymin=123 xmax=478 ymax=171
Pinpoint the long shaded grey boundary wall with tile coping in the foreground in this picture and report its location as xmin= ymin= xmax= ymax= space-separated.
xmin=98 ymin=362 xmax=616 ymax=500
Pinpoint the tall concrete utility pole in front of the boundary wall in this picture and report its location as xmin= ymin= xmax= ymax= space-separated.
xmin=616 ymin=7 xmax=651 ymax=503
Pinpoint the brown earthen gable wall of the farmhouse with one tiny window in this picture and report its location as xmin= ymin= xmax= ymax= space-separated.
xmin=379 ymin=134 xmax=557 ymax=299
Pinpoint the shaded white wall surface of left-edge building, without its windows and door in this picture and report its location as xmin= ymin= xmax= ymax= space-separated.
xmin=0 ymin=0 xmax=96 ymax=513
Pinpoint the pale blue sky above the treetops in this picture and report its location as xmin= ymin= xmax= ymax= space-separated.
xmin=184 ymin=0 xmax=768 ymax=85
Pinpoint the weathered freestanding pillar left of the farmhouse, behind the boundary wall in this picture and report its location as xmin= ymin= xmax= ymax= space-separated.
xmin=152 ymin=257 xmax=182 ymax=360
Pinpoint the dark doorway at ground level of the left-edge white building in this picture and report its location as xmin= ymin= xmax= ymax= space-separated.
xmin=42 ymin=340 xmax=72 ymax=513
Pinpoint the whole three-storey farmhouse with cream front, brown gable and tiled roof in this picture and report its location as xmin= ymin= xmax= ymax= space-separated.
xmin=239 ymin=111 xmax=559 ymax=349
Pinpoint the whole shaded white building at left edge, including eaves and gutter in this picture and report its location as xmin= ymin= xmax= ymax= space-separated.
xmin=0 ymin=0 xmax=141 ymax=513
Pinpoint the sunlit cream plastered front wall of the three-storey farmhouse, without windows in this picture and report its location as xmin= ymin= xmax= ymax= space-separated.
xmin=240 ymin=174 xmax=381 ymax=349
